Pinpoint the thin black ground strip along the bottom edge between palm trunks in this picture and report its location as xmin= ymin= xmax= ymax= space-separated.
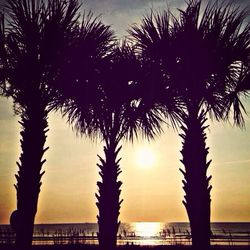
xmin=0 ymin=245 xmax=250 ymax=250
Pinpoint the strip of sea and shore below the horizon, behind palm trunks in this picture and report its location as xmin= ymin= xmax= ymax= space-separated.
xmin=0 ymin=222 xmax=250 ymax=250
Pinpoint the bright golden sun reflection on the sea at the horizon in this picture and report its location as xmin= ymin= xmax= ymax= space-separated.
xmin=132 ymin=222 xmax=164 ymax=237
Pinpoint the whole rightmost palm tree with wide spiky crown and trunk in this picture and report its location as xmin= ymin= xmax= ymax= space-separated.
xmin=130 ymin=0 xmax=250 ymax=250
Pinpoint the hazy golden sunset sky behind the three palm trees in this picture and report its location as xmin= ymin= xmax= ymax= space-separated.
xmin=0 ymin=0 xmax=250 ymax=224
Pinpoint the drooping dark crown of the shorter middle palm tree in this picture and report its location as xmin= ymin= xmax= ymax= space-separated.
xmin=61 ymin=40 xmax=167 ymax=141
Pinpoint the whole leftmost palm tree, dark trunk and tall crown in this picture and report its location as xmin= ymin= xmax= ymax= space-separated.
xmin=5 ymin=0 xmax=79 ymax=249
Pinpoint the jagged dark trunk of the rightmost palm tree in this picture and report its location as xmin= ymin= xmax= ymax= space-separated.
xmin=180 ymin=111 xmax=212 ymax=250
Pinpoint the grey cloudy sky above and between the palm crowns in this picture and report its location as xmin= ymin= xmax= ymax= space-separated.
xmin=83 ymin=0 xmax=249 ymax=37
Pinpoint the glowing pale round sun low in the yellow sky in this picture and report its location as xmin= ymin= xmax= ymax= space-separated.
xmin=135 ymin=147 xmax=155 ymax=168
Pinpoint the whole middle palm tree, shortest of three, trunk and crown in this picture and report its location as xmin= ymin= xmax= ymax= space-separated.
xmin=94 ymin=43 xmax=172 ymax=249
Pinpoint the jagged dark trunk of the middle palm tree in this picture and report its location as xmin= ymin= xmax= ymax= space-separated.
xmin=96 ymin=140 xmax=122 ymax=250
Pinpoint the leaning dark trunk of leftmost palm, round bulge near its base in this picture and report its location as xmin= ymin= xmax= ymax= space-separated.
xmin=11 ymin=103 xmax=48 ymax=250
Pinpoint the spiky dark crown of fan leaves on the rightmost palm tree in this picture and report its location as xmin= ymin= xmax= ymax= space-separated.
xmin=130 ymin=0 xmax=250 ymax=125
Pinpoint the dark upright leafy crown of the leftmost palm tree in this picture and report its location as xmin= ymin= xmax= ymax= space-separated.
xmin=6 ymin=0 xmax=79 ymax=113
